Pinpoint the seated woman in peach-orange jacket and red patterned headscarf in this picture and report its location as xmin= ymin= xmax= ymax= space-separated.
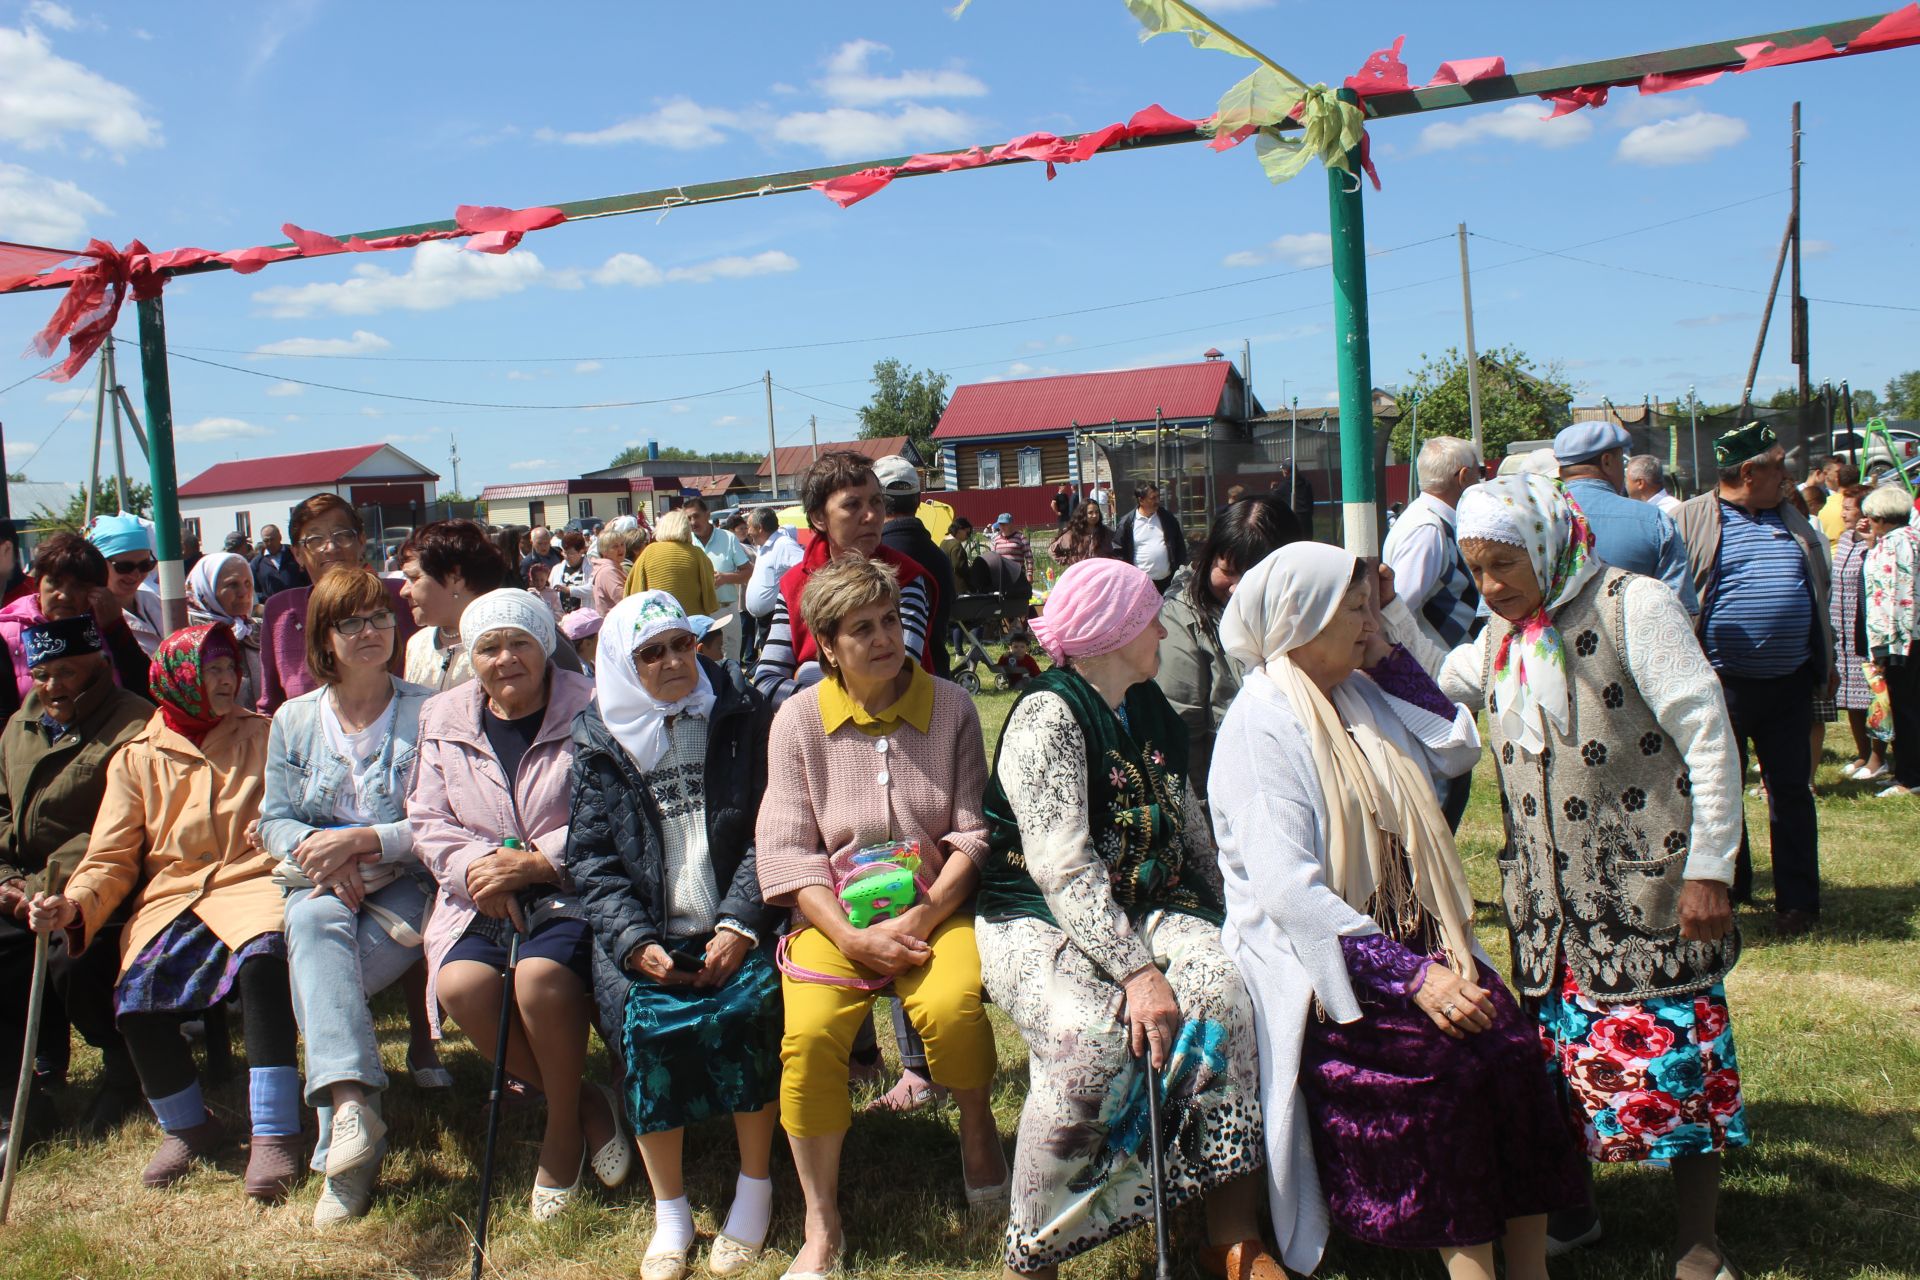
xmin=29 ymin=626 xmax=301 ymax=1201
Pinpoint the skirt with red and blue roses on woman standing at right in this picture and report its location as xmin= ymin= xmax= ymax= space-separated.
xmin=1540 ymin=961 xmax=1749 ymax=1163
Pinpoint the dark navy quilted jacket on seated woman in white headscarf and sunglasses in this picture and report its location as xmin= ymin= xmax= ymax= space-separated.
xmin=566 ymin=658 xmax=783 ymax=1046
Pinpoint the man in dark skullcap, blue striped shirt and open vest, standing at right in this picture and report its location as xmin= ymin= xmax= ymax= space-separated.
xmin=1680 ymin=422 xmax=1837 ymax=935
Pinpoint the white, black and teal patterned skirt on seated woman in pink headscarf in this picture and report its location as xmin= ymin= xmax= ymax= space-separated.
xmin=977 ymin=912 xmax=1267 ymax=1272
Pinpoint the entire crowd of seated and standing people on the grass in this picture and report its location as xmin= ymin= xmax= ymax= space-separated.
xmin=0 ymin=424 xmax=1889 ymax=1280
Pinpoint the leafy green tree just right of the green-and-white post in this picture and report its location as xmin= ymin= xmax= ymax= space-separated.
xmin=1392 ymin=345 xmax=1572 ymax=459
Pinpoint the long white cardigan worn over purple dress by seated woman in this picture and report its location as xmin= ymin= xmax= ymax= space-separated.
xmin=1208 ymin=672 xmax=1492 ymax=1272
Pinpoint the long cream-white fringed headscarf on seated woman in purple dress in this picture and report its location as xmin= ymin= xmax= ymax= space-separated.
xmin=1219 ymin=543 xmax=1478 ymax=981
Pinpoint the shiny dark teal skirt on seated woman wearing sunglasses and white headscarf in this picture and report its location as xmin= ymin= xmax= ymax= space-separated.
xmin=620 ymin=942 xmax=783 ymax=1134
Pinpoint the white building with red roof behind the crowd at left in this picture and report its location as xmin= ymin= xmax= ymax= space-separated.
xmin=180 ymin=445 xmax=440 ymax=551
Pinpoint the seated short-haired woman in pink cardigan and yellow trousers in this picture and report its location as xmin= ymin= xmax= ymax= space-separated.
xmin=756 ymin=560 xmax=1006 ymax=1280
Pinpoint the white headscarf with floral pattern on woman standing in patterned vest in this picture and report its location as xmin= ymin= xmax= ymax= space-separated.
xmin=1455 ymin=476 xmax=1601 ymax=754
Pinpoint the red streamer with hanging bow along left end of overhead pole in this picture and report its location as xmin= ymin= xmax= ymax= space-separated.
xmin=0 ymin=205 xmax=566 ymax=382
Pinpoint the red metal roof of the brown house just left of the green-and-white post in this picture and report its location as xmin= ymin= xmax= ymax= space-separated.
xmin=933 ymin=361 xmax=1233 ymax=439
